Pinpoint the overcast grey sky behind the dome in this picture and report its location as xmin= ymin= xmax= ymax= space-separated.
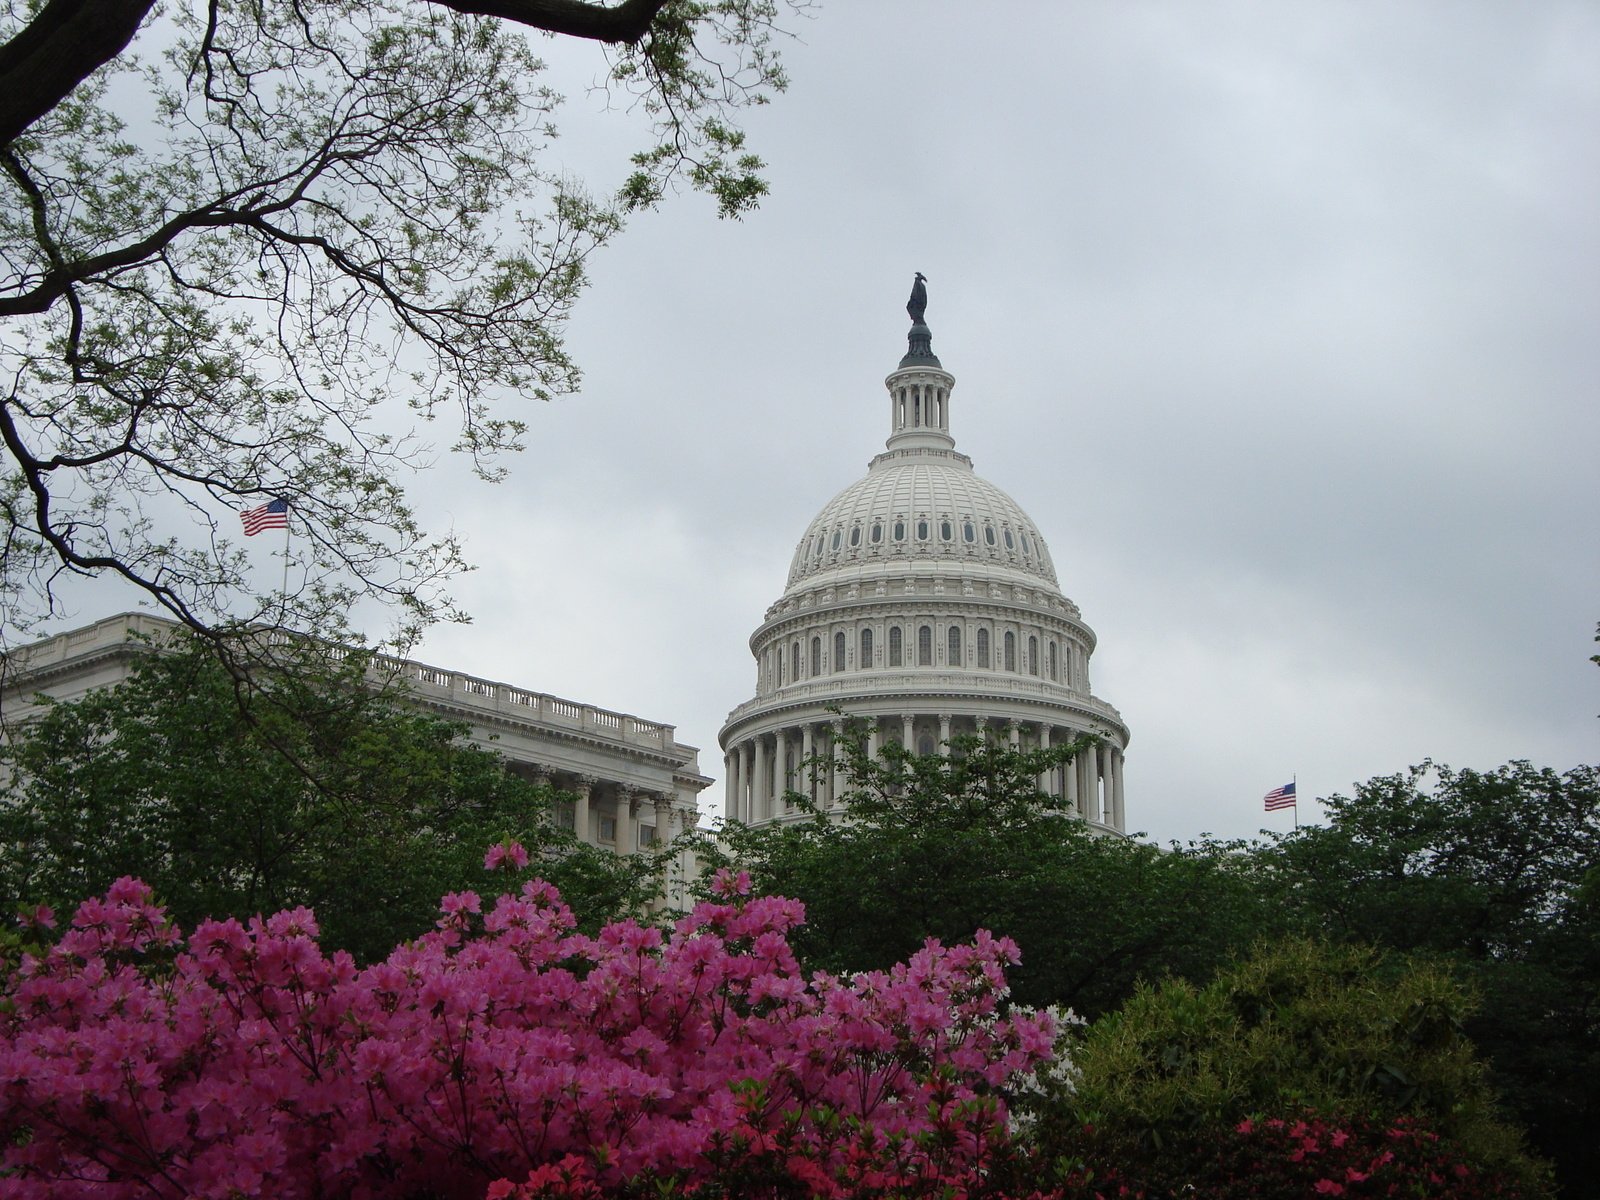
xmin=62 ymin=0 xmax=1600 ymax=840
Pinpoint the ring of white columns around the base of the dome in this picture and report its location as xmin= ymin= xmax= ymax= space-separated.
xmin=723 ymin=714 xmax=1125 ymax=830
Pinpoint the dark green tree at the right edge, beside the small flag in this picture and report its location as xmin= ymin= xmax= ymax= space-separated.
xmin=1261 ymin=762 xmax=1600 ymax=1195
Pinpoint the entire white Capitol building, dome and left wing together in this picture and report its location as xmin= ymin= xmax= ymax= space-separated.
xmin=0 ymin=275 xmax=1128 ymax=854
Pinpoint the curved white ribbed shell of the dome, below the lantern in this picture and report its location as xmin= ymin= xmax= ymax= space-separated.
xmin=787 ymin=450 xmax=1056 ymax=589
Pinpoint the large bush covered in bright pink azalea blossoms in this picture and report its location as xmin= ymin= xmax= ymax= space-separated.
xmin=0 ymin=864 xmax=1054 ymax=1200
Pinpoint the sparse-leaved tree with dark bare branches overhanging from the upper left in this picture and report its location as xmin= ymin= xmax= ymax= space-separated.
xmin=0 ymin=0 xmax=803 ymax=649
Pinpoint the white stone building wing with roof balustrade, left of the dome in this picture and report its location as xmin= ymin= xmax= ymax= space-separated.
xmin=0 ymin=613 xmax=710 ymax=857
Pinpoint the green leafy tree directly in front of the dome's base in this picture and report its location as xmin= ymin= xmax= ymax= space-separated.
xmin=701 ymin=728 xmax=1274 ymax=1016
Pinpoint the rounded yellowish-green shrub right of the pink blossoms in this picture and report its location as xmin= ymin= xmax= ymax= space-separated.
xmin=1043 ymin=939 xmax=1542 ymax=1187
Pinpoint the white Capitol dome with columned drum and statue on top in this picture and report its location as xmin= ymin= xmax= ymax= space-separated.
xmin=720 ymin=284 xmax=1128 ymax=834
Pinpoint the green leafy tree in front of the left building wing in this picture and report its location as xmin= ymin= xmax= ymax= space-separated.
xmin=0 ymin=640 xmax=662 ymax=958
